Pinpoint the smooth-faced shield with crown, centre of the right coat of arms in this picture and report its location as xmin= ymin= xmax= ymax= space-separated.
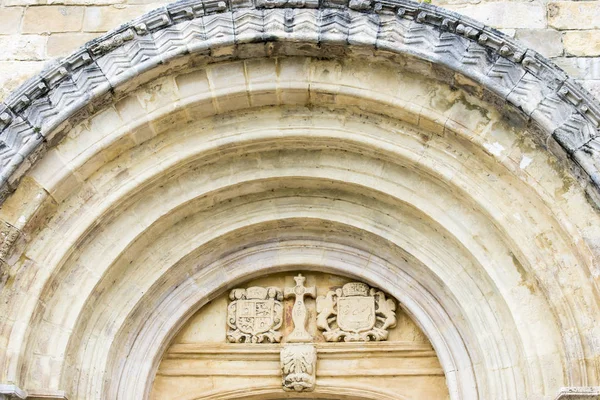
xmin=337 ymin=282 xmax=376 ymax=333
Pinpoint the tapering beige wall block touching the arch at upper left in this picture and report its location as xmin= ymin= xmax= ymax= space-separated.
xmin=83 ymin=3 xmax=160 ymax=32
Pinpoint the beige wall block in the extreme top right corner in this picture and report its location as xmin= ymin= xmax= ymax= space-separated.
xmin=548 ymin=1 xmax=600 ymax=29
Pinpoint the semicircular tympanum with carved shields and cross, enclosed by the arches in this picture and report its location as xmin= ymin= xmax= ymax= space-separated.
xmin=150 ymin=271 xmax=448 ymax=400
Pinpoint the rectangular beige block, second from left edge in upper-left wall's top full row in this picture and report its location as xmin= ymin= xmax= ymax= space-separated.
xmin=22 ymin=6 xmax=84 ymax=33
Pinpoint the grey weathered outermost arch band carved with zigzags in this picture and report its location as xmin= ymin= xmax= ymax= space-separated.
xmin=0 ymin=0 xmax=600 ymax=201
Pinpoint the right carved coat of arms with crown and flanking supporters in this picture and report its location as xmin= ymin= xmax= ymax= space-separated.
xmin=317 ymin=282 xmax=396 ymax=342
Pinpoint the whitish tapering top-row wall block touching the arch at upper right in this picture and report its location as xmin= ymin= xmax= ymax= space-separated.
xmin=445 ymin=2 xmax=546 ymax=29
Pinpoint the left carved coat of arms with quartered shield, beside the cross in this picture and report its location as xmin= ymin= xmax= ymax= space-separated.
xmin=227 ymin=286 xmax=283 ymax=343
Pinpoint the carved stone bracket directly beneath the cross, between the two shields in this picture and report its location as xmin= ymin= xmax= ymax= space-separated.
xmin=280 ymin=343 xmax=317 ymax=392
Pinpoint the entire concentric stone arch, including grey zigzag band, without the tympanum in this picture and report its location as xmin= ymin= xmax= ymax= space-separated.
xmin=2 ymin=2 xmax=599 ymax=399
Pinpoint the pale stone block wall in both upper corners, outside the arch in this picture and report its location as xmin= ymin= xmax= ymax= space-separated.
xmin=0 ymin=0 xmax=600 ymax=99
